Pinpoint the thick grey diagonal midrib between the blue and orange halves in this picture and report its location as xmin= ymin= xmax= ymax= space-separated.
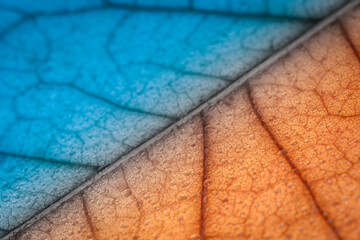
xmin=1 ymin=0 xmax=360 ymax=240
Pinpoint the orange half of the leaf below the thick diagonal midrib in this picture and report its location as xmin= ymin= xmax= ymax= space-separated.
xmin=6 ymin=1 xmax=360 ymax=240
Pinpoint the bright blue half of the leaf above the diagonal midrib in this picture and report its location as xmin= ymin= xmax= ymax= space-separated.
xmin=0 ymin=0 xmax=344 ymax=235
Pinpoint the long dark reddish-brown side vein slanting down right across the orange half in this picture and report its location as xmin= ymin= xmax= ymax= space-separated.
xmin=245 ymin=83 xmax=342 ymax=240
